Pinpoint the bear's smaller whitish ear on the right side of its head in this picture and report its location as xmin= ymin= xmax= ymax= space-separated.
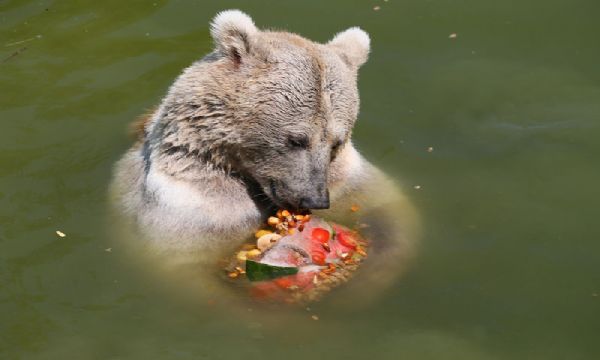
xmin=327 ymin=27 xmax=371 ymax=68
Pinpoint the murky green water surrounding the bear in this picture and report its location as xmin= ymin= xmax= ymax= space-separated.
xmin=0 ymin=0 xmax=600 ymax=359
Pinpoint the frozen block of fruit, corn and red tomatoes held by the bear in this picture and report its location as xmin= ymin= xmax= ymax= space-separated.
xmin=227 ymin=210 xmax=367 ymax=303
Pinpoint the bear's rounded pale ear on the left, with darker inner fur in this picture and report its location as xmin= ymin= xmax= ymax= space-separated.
xmin=210 ymin=10 xmax=258 ymax=63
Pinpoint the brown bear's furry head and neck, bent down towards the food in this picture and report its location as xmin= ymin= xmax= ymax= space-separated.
xmin=149 ymin=10 xmax=370 ymax=209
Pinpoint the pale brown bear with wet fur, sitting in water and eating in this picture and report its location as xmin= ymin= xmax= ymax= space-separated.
xmin=112 ymin=11 xmax=413 ymax=272
